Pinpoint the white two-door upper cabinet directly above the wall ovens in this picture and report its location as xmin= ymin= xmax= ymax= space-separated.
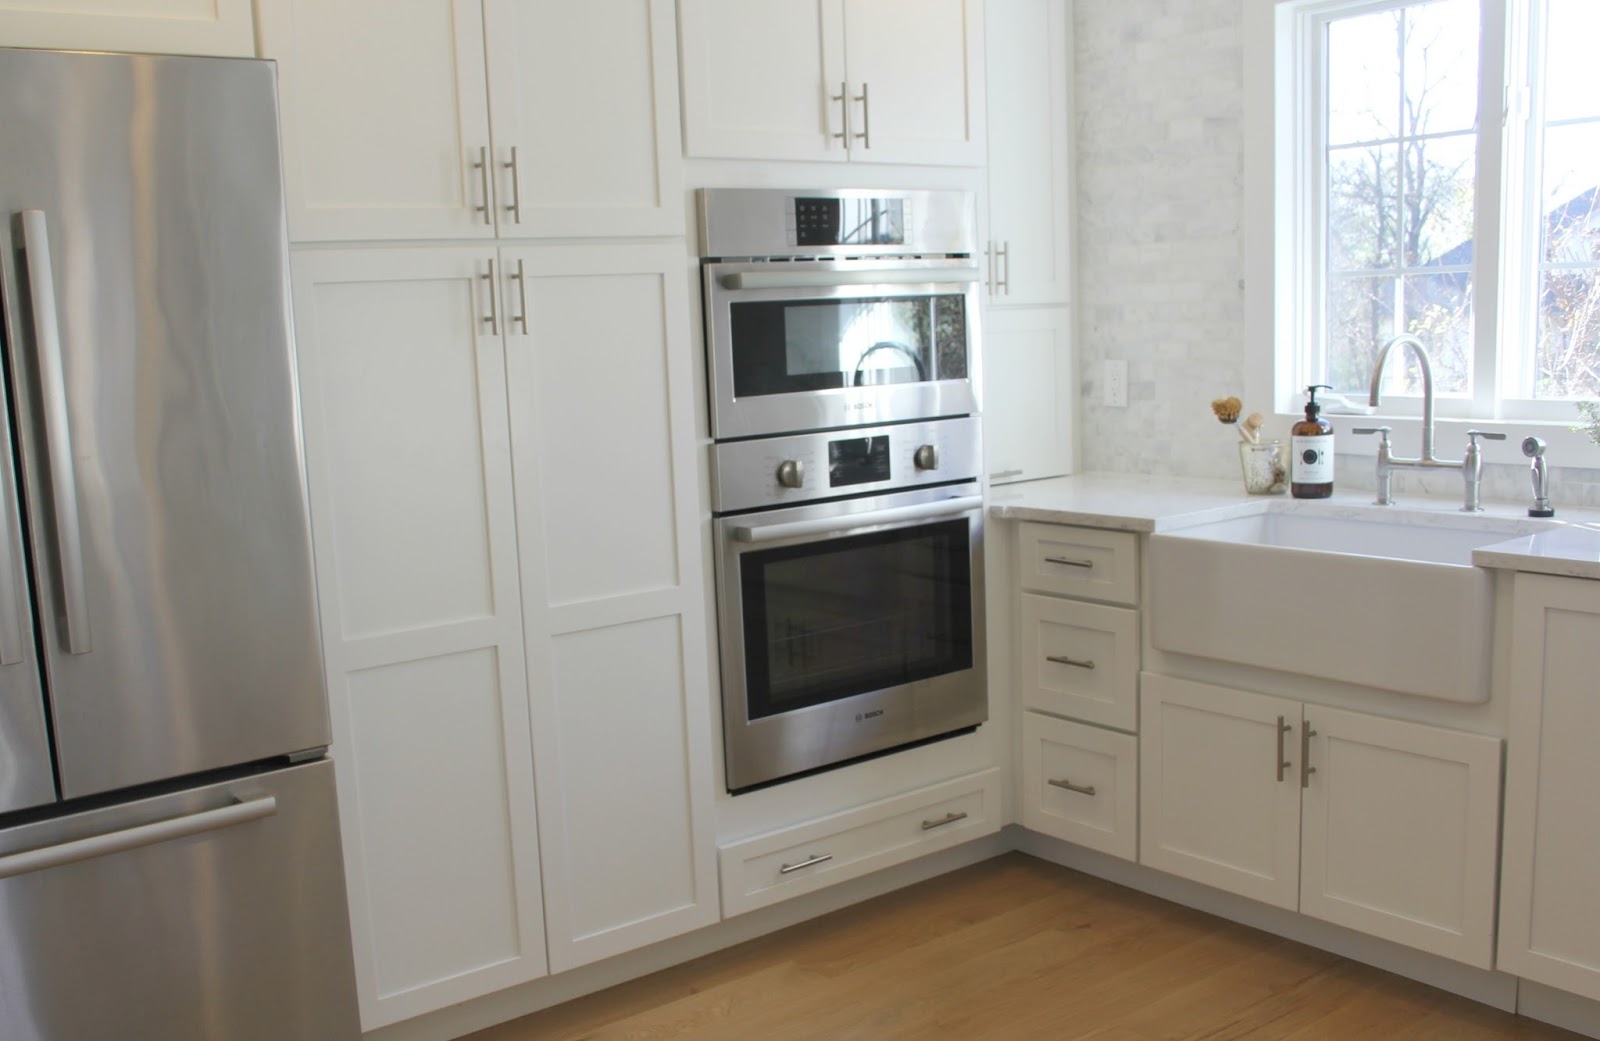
xmin=678 ymin=0 xmax=984 ymax=166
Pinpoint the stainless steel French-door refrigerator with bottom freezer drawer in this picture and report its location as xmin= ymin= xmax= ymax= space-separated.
xmin=0 ymin=50 xmax=358 ymax=1041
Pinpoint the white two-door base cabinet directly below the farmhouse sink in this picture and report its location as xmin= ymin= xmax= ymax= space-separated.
xmin=1139 ymin=673 xmax=1501 ymax=969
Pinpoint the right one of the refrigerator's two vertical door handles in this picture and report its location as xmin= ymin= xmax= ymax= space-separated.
xmin=22 ymin=209 xmax=90 ymax=654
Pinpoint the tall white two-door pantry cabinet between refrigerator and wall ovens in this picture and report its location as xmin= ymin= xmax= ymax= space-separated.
xmin=293 ymin=245 xmax=718 ymax=1030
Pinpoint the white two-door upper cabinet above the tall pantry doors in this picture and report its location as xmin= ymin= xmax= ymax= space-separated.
xmin=258 ymin=0 xmax=683 ymax=241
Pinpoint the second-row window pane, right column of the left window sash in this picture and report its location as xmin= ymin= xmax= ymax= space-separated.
xmin=1405 ymin=136 xmax=1477 ymax=267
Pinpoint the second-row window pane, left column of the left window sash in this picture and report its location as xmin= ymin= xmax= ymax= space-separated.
xmin=1328 ymin=144 xmax=1400 ymax=273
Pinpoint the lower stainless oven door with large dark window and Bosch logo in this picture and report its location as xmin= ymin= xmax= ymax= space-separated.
xmin=717 ymin=485 xmax=989 ymax=792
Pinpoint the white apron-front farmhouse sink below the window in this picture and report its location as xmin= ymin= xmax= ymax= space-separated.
xmin=1150 ymin=510 xmax=1531 ymax=704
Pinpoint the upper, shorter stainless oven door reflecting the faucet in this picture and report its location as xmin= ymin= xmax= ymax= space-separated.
xmin=704 ymin=259 xmax=978 ymax=440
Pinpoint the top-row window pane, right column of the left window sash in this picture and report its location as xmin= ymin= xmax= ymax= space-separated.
xmin=1402 ymin=0 xmax=1478 ymax=134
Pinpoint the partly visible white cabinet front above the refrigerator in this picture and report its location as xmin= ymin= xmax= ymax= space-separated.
xmin=0 ymin=0 xmax=256 ymax=58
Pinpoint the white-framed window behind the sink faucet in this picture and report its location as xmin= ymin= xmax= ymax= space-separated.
xmin=1270 ymin=0 xmax=1600 ymax=421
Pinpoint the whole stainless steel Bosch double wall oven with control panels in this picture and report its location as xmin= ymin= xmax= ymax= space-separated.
xmin=701 ymin=189 xmax=987 ymax=792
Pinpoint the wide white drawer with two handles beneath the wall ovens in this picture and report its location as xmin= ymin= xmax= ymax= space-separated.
xmin=718 ymin=769 xmax=1000 ymax=916
